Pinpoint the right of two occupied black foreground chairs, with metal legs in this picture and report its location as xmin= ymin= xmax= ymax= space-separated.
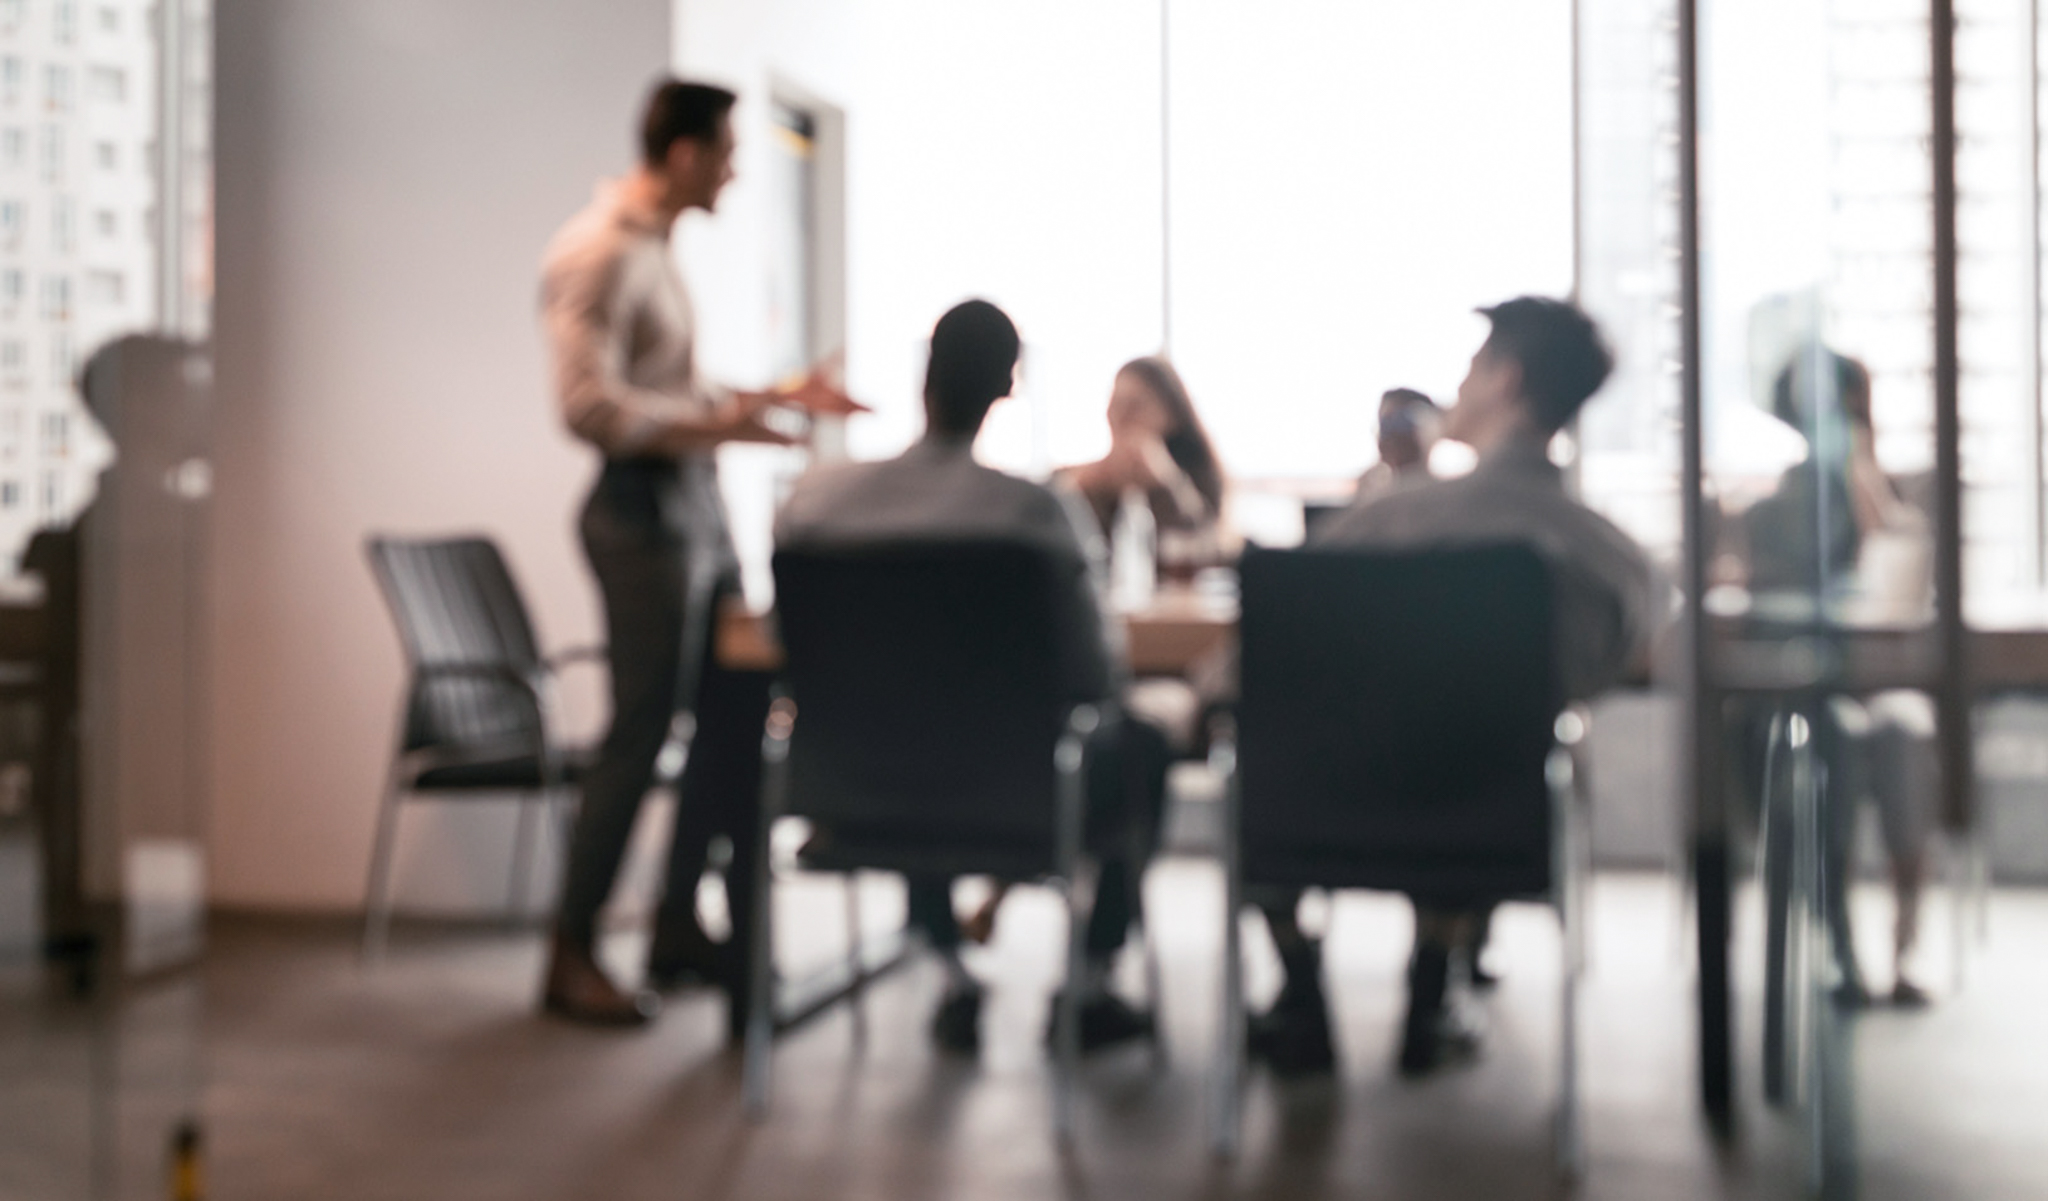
xmin=1212 ymin=545 xmax=1583 ymax=1172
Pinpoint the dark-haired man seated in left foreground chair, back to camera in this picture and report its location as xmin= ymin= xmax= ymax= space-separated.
xmin=776 ymin=299 xmax=1167 ymax=1053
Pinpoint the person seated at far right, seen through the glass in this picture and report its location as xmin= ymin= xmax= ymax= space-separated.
xmin=1726 ymin=346 xmax=1939 ymax=1008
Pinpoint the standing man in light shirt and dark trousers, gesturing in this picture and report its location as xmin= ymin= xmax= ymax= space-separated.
xmin=541 ymin=80 xmax=860 ymax=1029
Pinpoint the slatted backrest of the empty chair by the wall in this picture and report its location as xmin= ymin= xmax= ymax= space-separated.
xmin=367 ymin=537 xmax=541 ymax=750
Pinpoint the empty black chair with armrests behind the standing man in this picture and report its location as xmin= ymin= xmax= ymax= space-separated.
xmin=362 ymin=537 xmax=604 ymax=957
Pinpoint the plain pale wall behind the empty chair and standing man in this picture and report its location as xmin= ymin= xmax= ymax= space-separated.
xmin=211 ymin=0 xmax=670 ymax=908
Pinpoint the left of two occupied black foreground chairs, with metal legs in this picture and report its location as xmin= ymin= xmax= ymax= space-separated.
xmin=745 ymin=541 xmax=1146 ymax=1133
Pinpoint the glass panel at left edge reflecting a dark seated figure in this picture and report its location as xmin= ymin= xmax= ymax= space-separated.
xmin=0 ymin=0 xmax=213 ymax=1197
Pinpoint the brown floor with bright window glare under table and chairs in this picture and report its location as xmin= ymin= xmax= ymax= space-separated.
xmin=12 ymin=861 xmax=2048 ymax=1201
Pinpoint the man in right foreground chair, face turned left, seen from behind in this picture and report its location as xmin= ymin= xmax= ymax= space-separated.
xmin=1251 ymin=297 xmax=1663 ymax=1076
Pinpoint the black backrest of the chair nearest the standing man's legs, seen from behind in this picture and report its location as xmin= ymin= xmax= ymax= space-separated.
xmin=774 ymin=541 xmax=1065 ymax=861
